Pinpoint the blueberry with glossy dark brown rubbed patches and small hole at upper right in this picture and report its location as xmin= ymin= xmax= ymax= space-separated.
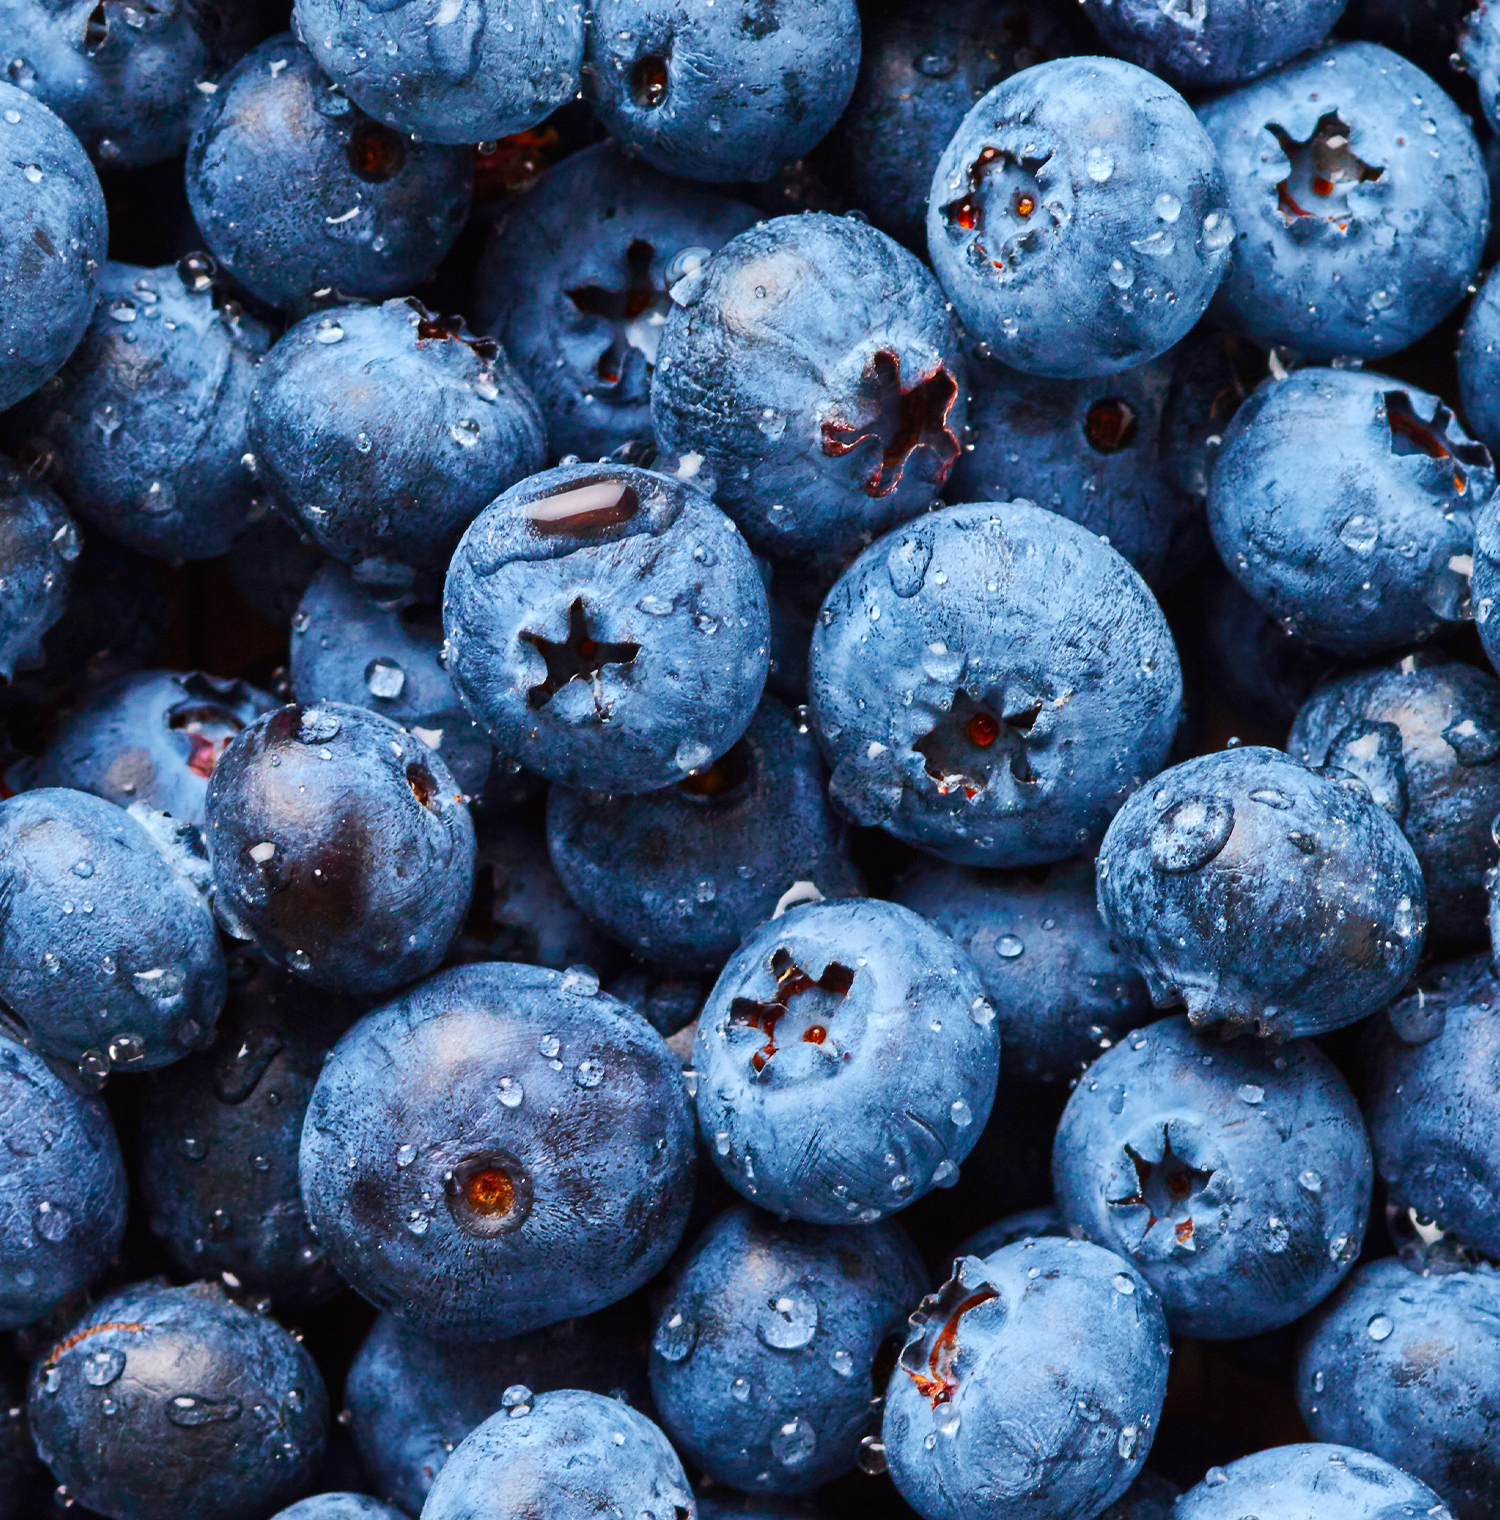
xmin=205 ymin=702 xmax=474 ymax=993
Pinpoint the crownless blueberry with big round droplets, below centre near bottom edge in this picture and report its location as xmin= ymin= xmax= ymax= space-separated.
xmin=650 ymin=1204 xmax=927 ymax=1493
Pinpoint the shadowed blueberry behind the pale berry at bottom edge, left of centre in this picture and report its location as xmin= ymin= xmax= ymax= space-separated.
xmin=345 ymin=1310 xmax=650 ymax=1515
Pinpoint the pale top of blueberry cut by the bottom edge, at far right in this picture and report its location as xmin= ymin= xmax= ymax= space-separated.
xmin=1172 ymin=1441 xmax=1447 ymax=1520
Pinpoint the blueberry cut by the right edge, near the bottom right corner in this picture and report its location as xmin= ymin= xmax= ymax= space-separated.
xmin=1296 ymin=1257 xmax=1500 ymax=1520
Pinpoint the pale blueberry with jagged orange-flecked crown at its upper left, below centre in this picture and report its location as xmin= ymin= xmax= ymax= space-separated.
xmin=693 ymin=898 xmax=1000 ymax=1224
